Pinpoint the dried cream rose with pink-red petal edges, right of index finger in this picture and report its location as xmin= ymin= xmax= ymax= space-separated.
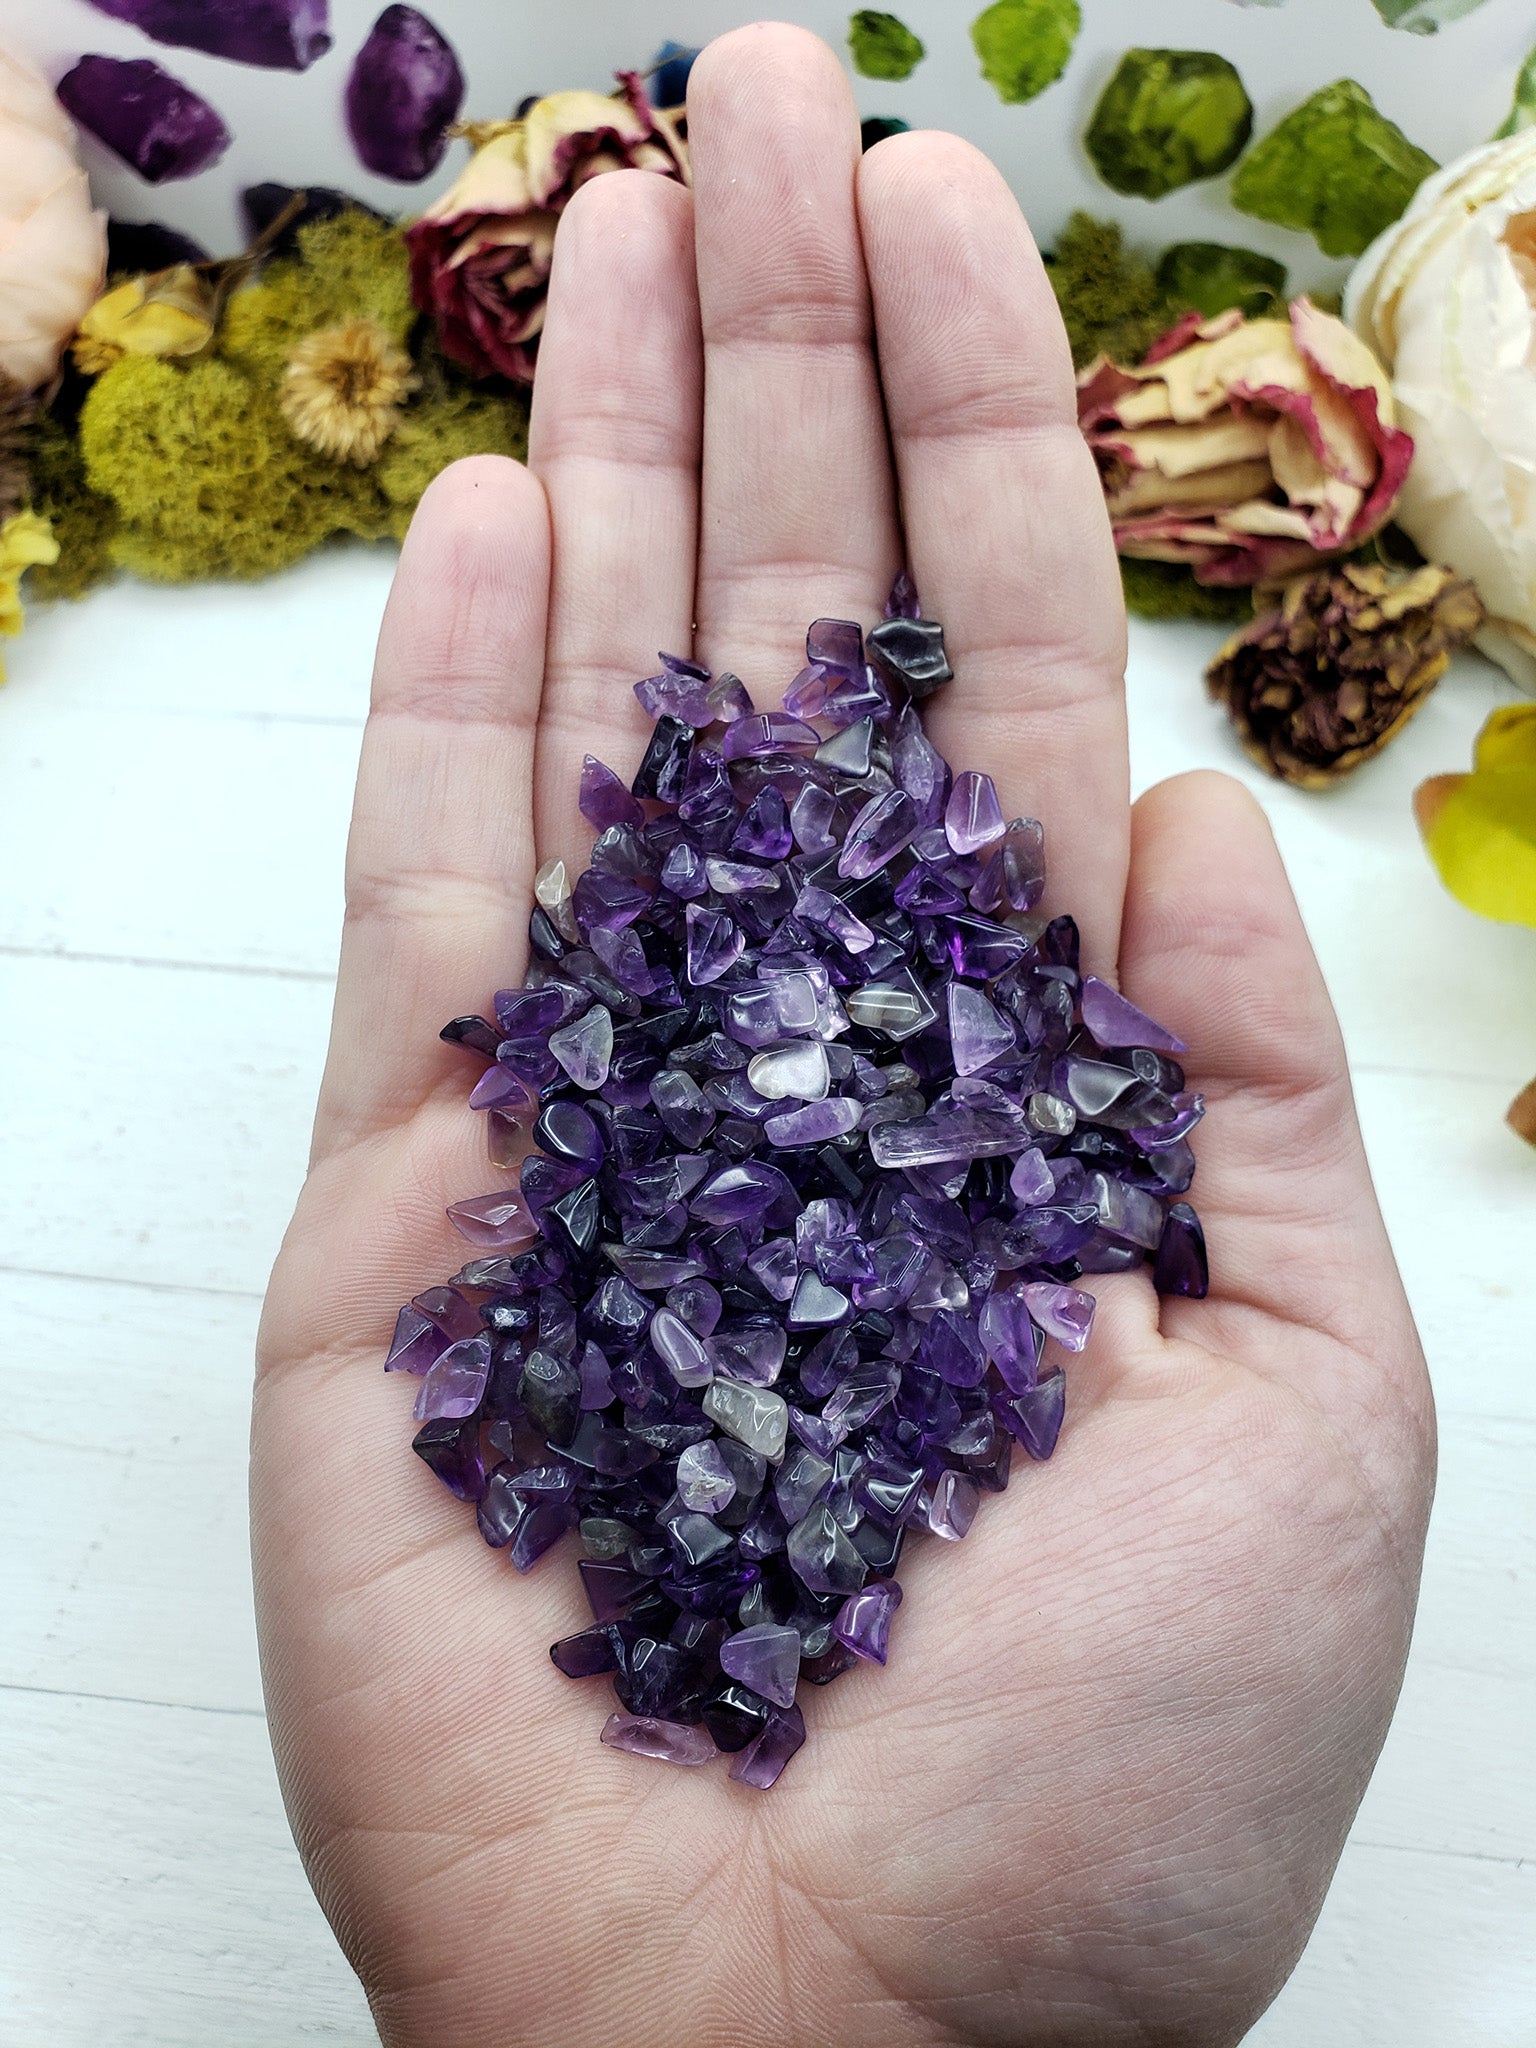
xmin=1077 ymin=299 xmax=1413 ymax=584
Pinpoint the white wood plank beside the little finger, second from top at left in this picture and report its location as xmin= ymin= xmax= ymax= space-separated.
xmin=0 ymin=690 xmax=360 ymax=979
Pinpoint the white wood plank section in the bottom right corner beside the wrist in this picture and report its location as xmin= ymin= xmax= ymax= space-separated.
xmin=1247 ymin=1841 xmax=1536 ymax=2048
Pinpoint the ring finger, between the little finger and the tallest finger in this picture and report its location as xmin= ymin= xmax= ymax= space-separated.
xmin=528 ymin=170 xmax=702 ymax=864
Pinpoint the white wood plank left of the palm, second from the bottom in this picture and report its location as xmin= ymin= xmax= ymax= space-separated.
xmin=0 ymin=1274 xmax=262 ymax=1714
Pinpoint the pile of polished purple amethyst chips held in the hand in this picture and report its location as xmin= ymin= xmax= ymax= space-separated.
xmin=389 ymin=578 xmax=1206 ymax=1786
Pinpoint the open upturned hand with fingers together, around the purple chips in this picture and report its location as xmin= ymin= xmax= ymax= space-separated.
xmin=252 ymin=27 xmax=1434 ymax=2048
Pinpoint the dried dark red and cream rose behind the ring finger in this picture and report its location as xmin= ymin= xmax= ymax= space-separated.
xmin=406 ymin=72 xmax=688 ymax=383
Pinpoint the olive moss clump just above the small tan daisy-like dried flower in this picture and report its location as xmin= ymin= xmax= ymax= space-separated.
xmin=219 ymin=207 xmax=416 ymax=381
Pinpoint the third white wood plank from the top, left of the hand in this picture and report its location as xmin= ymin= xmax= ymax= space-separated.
xmin=0 ymin=958 xmax=332 ymax=1294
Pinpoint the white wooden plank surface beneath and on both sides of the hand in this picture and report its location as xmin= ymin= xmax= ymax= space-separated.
xmin=0 ymin=551 xmax=1536 ymax=2048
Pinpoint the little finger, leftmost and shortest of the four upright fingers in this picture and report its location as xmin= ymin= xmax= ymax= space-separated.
xmin=313 ymin=455 xmax=549 ymax=1159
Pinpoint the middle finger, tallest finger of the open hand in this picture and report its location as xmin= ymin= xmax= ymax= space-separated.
xmin=688 ymin=25 xmax=901 ymax=702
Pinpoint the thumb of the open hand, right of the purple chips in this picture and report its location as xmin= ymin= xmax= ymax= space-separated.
xmin=1120 ymin=772 xmax=1421 ymax=1399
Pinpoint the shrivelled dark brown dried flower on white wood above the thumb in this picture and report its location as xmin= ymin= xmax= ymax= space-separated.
xmin=1206 ymin=563 xmax=1483 ymax=788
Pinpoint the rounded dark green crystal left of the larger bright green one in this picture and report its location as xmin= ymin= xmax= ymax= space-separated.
xmin=1083 ymin=49 xmax=1253 ymax=199
